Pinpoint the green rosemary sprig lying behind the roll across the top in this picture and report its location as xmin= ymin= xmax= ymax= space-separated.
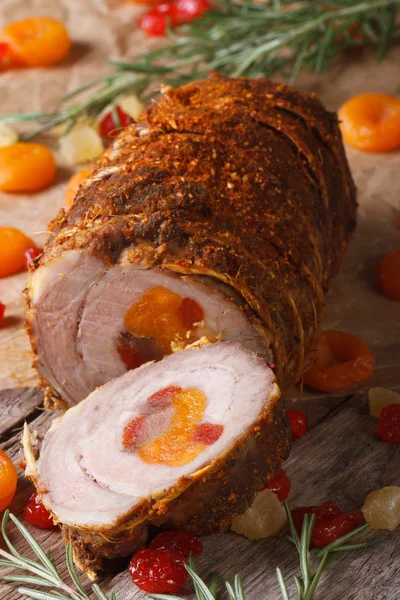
xmin=0 ymin=0 xmax=400 ymax=139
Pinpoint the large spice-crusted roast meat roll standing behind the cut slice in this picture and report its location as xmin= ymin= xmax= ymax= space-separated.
xmin=27 ymin=72 xmax=356 ymax=405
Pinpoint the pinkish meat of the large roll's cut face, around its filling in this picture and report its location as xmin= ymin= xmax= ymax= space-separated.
xmin=30 ymin=250 xmax=266 ymax=405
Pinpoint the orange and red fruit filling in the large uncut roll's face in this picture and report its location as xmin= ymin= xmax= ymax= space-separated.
xmin=118 ymin=286 xmax=204 ymax=369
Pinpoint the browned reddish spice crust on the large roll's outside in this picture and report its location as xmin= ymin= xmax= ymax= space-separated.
xmin=27 ymin=76 xmax=356 ymax=390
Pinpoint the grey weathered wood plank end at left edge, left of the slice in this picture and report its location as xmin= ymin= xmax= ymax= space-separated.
xmin=0 ymin=387 xmax=43 ymax=439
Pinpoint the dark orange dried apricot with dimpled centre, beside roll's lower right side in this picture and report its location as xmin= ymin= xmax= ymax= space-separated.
xmin=304 ymin=331 xmax=375 ymax=392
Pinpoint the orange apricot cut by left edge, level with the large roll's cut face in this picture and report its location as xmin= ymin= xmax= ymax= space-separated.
xmin=0 ymin=227 xmax=35 ymax=277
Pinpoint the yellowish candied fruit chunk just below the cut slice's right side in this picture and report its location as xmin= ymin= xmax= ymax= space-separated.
xmin=232 ymin=490 xmax=286 ymax=540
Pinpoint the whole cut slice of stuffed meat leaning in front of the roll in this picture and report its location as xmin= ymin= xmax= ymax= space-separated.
xmin=24 ymin=342 xmax=290 ymax=574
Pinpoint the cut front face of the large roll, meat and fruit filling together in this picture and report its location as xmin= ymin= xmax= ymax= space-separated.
xmin=31 ymin=250 xmax=268 ymax=405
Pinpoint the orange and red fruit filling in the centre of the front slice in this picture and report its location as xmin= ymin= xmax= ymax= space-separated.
xmin=122 ymin=386 xmax=223 ymax=466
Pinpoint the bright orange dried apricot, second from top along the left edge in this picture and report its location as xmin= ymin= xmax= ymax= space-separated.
xmin=0 ymin=142 xmax=56 ymax=192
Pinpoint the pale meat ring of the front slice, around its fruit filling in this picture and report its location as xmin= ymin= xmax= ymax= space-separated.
xmin=38 ymin=343 xmax=277 ymax=527
